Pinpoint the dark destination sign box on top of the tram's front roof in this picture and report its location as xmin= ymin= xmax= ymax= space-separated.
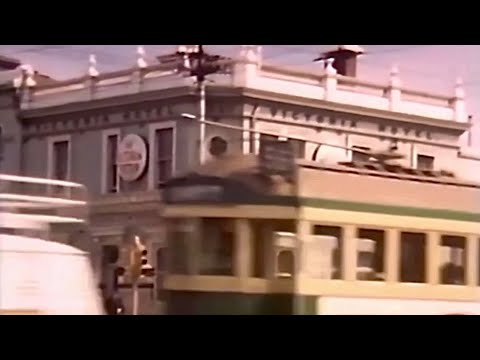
xmin=259 ymin=140 xmax=295 ymax=181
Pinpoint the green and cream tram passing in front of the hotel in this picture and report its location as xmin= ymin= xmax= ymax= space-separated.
xmin=162 ymin=147 xmax=480 ymax=315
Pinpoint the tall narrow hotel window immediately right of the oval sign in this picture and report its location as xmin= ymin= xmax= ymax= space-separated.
xmin=155 ymin=128 xmax=173 ymax=185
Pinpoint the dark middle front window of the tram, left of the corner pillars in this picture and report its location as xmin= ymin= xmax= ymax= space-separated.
xmin=199 ymin=219 xmax=235 ymax=276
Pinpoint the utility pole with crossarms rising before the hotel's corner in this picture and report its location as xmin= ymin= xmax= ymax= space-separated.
xmin=177 ymin=45 xmax=230 ymax=164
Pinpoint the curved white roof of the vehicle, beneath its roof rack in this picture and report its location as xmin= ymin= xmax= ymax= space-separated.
xmin=0 ymin=235 xmax=86 ymax=255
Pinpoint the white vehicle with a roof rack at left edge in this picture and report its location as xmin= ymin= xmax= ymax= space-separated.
xmin=0 ymin=175 xmax=104 ymax=315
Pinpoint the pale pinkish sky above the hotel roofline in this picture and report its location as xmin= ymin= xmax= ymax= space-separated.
xmin=0 ymin=45 xmax=480 ymax=150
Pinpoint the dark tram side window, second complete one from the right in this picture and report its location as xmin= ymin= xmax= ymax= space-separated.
xmin=400 ymin=232 xmax=426 ymax=283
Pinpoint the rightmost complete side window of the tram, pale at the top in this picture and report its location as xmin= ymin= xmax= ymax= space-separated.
xmin=440 ymin=235 xmax=467 ymax=285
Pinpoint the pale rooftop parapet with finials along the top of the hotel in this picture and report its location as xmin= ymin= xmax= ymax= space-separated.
xmin=16 ymin=45 xmax=467 ymax=122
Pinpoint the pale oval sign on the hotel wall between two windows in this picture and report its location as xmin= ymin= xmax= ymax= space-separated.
xmin=117 ymin=134 xmax=147 ymax=181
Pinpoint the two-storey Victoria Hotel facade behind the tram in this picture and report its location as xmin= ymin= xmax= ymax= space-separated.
xmin=6 ymin=45 xmax=480 ymax=312
